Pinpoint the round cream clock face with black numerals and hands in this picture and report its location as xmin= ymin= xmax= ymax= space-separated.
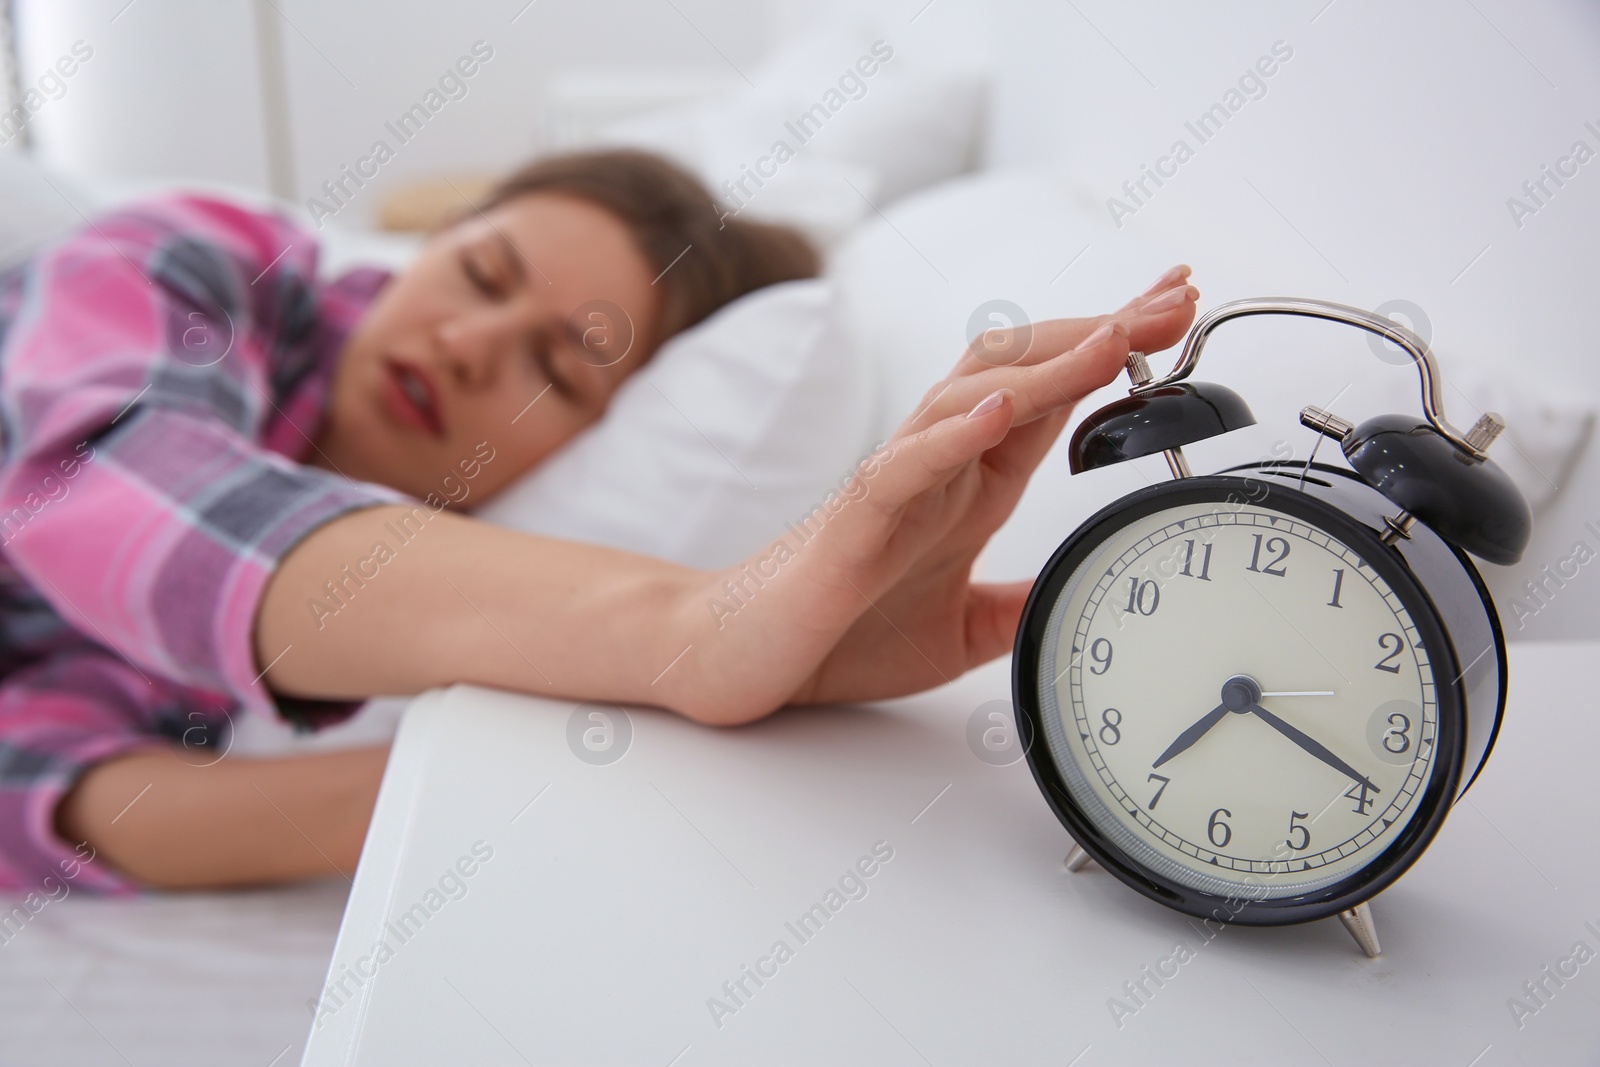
xmin=1037 ymin=496 xmax=1453 ymax=901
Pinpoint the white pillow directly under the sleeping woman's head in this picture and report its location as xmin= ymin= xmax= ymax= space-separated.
xmin=475 ymin=280 xmax=877 ymax=568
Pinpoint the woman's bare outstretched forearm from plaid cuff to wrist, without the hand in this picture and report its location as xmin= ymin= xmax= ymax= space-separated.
xmin=256 ymin=506 xmax=706 ymax=712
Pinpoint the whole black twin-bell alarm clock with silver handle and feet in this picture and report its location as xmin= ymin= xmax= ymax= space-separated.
xmin=1011 ymin=298 xmax=1533 ymax=957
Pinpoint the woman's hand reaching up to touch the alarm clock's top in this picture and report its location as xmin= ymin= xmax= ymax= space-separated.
xmin=674 ymin=267 xmax=1198 ymax=723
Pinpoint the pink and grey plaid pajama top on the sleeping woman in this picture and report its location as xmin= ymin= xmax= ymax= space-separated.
xmin=0 ymin=197 xmax=408 ymax=891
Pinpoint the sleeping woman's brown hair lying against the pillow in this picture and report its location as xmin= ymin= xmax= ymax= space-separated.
xmin=482 ymin=149 xmax=819 ymax=339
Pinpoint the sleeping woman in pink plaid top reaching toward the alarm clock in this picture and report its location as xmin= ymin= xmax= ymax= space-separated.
xmin=0 ymin=152 xmax=1198 ymax=891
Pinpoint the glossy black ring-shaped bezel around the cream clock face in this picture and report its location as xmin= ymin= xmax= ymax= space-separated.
xmin=1011 ymin=475 xmax=1467 ymax=926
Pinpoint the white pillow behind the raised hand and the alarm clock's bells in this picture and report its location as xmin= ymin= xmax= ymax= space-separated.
xmin=829 ymin=170 xmax=1600 ymax=638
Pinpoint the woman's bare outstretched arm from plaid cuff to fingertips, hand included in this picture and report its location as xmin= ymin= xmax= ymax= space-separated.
xmin=256 ymin=274 xmax=1197 ymax=725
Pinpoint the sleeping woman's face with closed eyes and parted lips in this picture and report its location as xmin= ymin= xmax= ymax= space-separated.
xmin=312 ymin=194 xmax=661 ymax=507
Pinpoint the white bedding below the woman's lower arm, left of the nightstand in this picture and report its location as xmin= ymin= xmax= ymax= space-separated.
xmin=0 ymin=880 xmax=349 ymax=1067
